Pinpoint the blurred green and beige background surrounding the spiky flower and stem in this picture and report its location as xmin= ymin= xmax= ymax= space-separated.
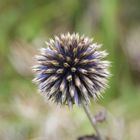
xmin=0 ymin=0 xmax=140 ymax=140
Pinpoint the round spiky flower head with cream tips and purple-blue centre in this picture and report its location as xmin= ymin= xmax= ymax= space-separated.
xmin=33 ymin=33 xmax=110 ymax=106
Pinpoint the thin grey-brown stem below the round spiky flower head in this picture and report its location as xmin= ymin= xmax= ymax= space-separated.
xmin=82 ymin=101 xmax=102 ymax=140
